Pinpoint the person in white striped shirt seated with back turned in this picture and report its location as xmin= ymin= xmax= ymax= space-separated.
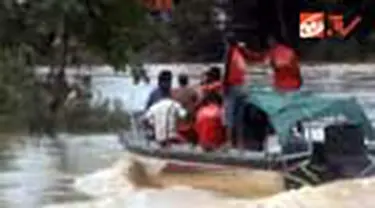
xmin=144 ymin=90 xmax=188 ymax=145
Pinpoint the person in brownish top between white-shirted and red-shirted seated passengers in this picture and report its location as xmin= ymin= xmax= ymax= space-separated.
xmin=173 ymin=74 xmax=198 ymax=143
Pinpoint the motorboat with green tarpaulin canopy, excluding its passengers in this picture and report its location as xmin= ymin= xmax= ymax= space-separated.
xmin=119 ymin=86 xmax=374 ymax=176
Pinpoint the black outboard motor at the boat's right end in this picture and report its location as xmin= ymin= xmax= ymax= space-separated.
xmin=324 ymin=123 xmax=373 ymax=178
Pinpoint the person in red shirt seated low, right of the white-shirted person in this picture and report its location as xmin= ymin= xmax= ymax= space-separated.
xmin=195 ymin=92 xmax=225 ymax=150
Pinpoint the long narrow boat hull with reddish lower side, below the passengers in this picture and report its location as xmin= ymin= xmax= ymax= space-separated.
xmin=120 ymin=133 xmax=309 ymax=172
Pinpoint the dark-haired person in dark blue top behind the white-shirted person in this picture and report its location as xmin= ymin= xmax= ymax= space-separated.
xmin=145 ymin=70 xmax=173 ymax=110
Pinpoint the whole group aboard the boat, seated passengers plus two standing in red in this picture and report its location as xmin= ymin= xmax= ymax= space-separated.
xmin=143 ymin=41 xmax=301 ymax=150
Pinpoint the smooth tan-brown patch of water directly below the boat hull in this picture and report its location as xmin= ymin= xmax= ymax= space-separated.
xmin=155 ymin=169 xmax=283 ymax=199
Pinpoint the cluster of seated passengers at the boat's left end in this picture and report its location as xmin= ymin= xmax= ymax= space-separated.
xmin=144 ymin=67 xmax=226 ymax=150
